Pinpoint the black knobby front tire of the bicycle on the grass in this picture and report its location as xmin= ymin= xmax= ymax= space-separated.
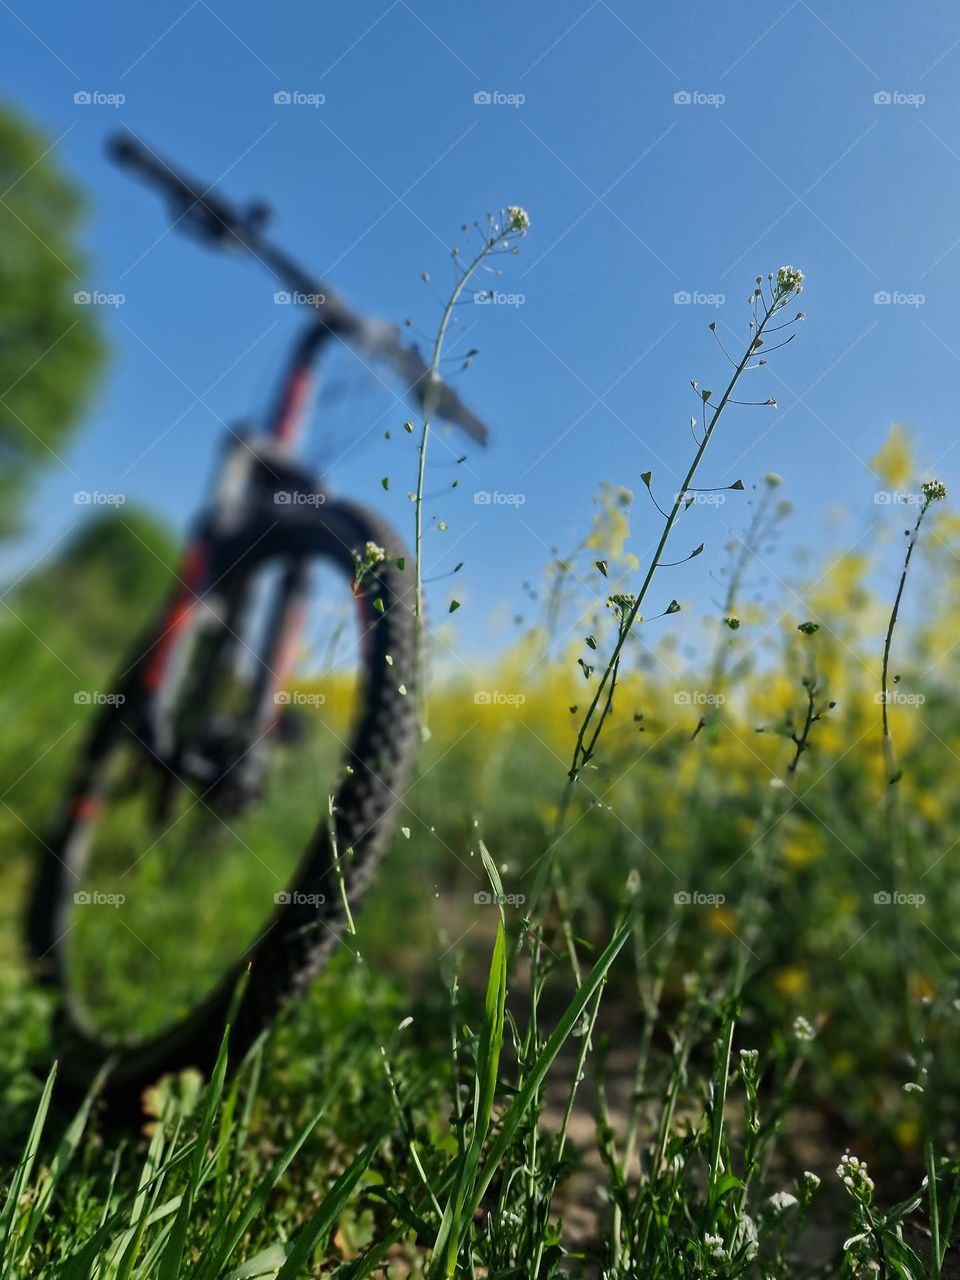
xmin=27 ymin=502 xmax=419 ymax=1115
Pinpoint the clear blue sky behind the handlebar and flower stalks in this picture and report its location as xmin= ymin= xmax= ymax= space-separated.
xmin=0 ymin=0 xmax=960 ymax=653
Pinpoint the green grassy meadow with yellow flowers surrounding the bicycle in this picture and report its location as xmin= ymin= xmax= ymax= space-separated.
xmin=0 ymin=264 xmax=960 ymax=1280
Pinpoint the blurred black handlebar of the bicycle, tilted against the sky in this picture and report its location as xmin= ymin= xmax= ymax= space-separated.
xmin=108 ymin=133 xmax=488 ymax=444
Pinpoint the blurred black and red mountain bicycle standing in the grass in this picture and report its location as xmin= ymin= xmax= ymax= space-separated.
xmin=27 ymin=134 xmax=486 ymax=1108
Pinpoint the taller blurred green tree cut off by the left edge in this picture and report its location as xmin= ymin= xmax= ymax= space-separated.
xmin=0 ymin=106 xmax=105 ymax=535
